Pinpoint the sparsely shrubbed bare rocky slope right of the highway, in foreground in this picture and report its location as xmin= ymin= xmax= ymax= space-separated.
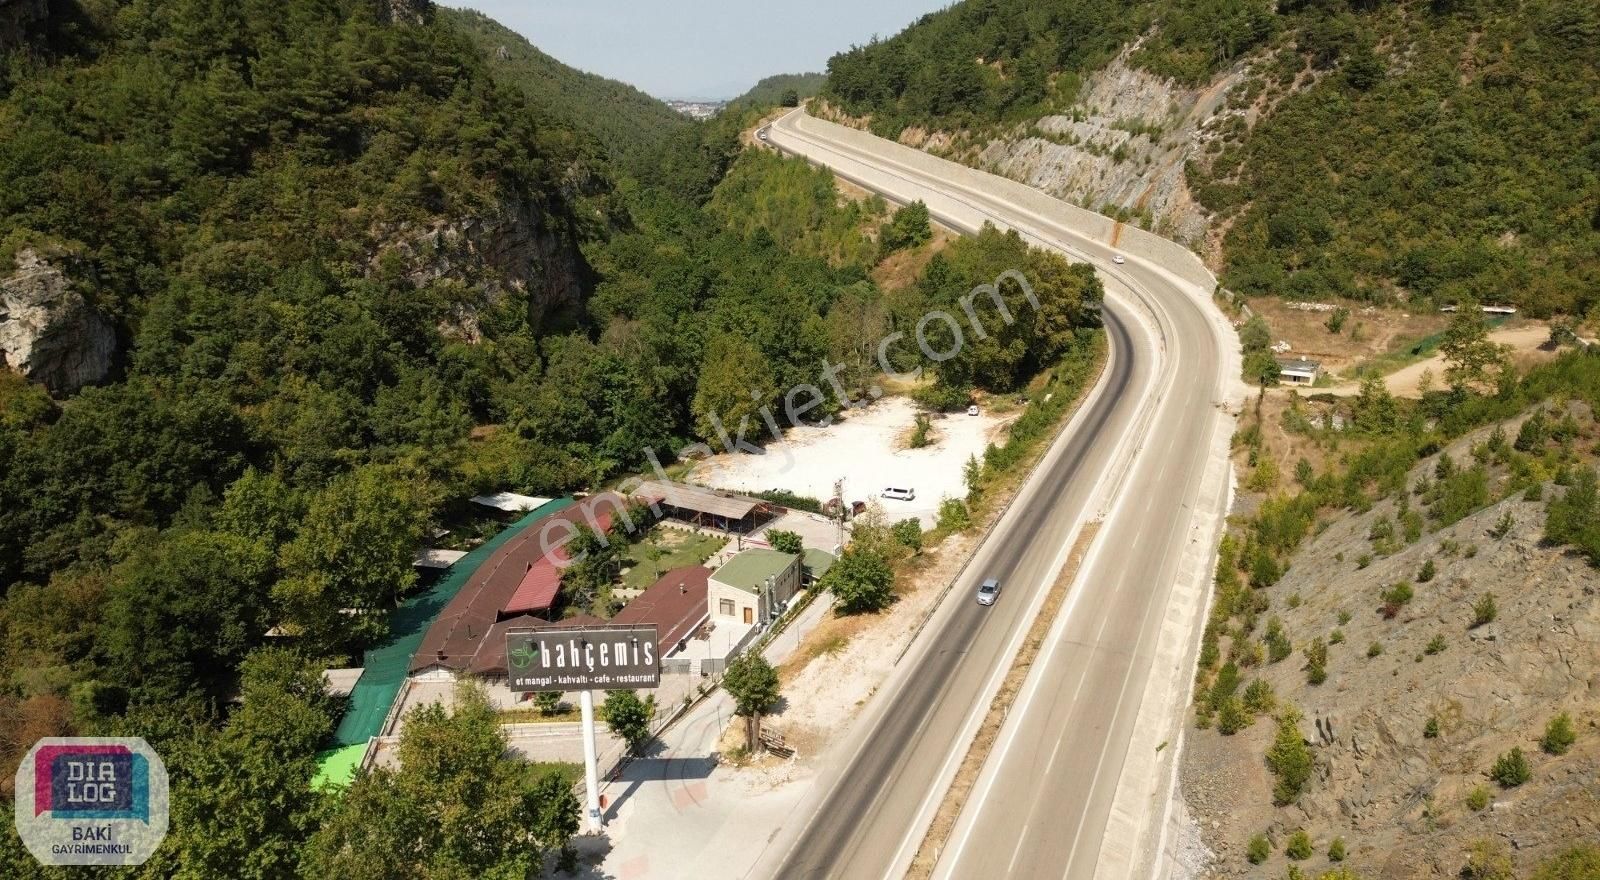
xmin=1182 ymin=317 xmax=1600 ymax=880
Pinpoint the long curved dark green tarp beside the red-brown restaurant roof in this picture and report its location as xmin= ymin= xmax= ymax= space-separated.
xmin=333 ymin=498 xmax=573 ymax=746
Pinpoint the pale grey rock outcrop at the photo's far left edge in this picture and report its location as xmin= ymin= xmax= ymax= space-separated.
xmin=0 ymin=248 xmax=117 ymax=394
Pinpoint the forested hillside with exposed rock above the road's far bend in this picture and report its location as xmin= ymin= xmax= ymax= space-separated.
xmin=824 ymin=0 xmax=1600 ymax=314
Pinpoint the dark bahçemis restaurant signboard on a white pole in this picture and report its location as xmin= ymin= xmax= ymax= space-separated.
xmin=506 ymin=626 xmax=661 ymax=691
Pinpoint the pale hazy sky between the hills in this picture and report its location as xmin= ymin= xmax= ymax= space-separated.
xmin=442 ymin=0 xmax=950 ymax=98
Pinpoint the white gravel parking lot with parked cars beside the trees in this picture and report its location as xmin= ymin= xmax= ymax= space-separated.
xmin=690 ymin=397 xmax=1011 ymax=526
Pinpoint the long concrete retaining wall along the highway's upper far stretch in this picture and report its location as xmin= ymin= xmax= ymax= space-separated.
xmin=795 ymin=114 xmax=1216 ymax=294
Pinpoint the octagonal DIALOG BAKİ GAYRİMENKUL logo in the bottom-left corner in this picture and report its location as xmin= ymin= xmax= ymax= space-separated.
xmin=16 ymin=736 xmax=168 ymax=864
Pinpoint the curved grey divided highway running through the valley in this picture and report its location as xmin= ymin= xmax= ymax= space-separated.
xmin=754 ymin=110 xmax=1234 ymax=878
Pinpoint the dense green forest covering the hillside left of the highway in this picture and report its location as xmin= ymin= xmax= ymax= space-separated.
xmin=0 ymin=0 xmax=1101 ymax=878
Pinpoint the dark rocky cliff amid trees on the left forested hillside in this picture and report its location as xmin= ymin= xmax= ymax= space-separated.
xmin=370 ymin=200 xmax=587 ymax=341
